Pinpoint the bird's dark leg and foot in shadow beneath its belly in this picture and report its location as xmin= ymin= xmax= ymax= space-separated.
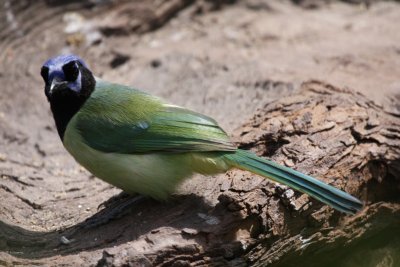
xmin=82 ymin=192 xmax=146 ymax=228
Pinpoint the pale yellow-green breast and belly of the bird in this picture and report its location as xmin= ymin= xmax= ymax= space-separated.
xmin=63 ymin=118 xmax=197 ymax=199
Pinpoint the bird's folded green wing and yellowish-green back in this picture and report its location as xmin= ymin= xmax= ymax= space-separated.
xmin=75 ymin=81 xmax=236 ymax=154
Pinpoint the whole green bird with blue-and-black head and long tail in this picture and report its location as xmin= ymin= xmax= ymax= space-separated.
xmin=40 ymin=54 xmax=363 ymax=214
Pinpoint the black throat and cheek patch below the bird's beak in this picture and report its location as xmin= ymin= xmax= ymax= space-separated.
xmin=45 ymin=66 xmax=96 ymax=141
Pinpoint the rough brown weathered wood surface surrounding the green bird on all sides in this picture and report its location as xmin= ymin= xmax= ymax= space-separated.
xmin=0 ymin=0 xmax=400 ymax=267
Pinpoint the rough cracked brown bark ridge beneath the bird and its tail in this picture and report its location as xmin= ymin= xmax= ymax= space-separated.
xmin=0 ymin=81 xmax=400 ymax=266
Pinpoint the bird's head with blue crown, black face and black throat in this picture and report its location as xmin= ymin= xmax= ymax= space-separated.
xmin=40 ymin=55 xmax=96 ymax=139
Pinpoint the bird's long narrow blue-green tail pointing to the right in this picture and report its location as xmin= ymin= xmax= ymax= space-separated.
xmin=226 ymin=149 xmax=363 ymax=214
